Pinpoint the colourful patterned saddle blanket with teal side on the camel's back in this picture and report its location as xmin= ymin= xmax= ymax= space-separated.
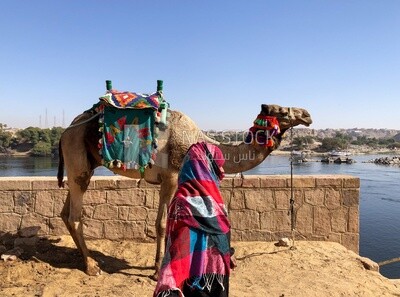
xmin=96 ymin=90 xmax=168 ymax=177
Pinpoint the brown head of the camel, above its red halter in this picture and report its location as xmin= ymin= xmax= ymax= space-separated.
xmin=261 ymin=104 xmax=312 ymax=134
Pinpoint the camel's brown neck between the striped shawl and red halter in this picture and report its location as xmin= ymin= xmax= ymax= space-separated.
xmin=218 ymin=143 xmax=273 ymax=173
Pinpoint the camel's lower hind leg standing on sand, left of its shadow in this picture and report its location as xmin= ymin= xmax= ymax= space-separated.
xmin=61 ymin=174 xmax=101 ymax=275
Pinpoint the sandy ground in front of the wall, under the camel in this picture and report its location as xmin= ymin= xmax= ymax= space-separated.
xmin=0 ymin=236 xmax=400 ymax=297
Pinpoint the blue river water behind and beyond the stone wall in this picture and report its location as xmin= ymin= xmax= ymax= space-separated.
xmin=0 ymin=155 xmax=400 ymax=278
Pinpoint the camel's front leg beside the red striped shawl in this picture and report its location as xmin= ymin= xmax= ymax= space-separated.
xmin=153 ymin=178 xmax=177 ymax=280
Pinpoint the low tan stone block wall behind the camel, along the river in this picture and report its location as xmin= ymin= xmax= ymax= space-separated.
xmin=0 ymin=175 xmax=360 ymax=253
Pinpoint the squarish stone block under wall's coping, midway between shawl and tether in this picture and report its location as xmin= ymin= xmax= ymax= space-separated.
xmin=244 ymin=189 xmax=275 ymax=212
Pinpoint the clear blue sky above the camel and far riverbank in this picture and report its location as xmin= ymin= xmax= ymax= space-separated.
xmin=0 ymin=0 xmax=400 ymax=130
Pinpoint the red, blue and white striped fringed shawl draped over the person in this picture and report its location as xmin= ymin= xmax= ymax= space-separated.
xmin=154 ymin=143 xmax=230 ymax=296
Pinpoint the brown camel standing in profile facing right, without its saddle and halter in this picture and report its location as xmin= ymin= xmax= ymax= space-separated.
xmin=57 ymin=104 xmax=312 ymax=279
